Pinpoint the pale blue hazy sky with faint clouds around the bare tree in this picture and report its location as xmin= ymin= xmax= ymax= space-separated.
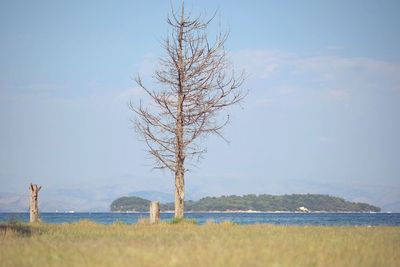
xmin=0 ymin=0 xmax=400 ymax=199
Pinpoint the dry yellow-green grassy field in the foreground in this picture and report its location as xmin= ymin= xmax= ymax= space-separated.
xmin=0 ymin=221 xmax=400 ymax=267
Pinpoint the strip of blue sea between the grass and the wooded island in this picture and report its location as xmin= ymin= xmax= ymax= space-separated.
xmin=0 ymin=212 xmax=400 ymax=226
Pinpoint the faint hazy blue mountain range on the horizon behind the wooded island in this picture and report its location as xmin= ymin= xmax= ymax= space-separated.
xmin=0 ymin=181 xmax=400 ymax=212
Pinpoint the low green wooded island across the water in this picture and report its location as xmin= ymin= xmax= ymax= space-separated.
xmin=110 ymin=194 xmax=381 ymax=212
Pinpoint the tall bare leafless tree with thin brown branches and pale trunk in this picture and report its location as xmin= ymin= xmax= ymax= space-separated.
xmin=130 ymin=3 xmax=244 ymax=218
